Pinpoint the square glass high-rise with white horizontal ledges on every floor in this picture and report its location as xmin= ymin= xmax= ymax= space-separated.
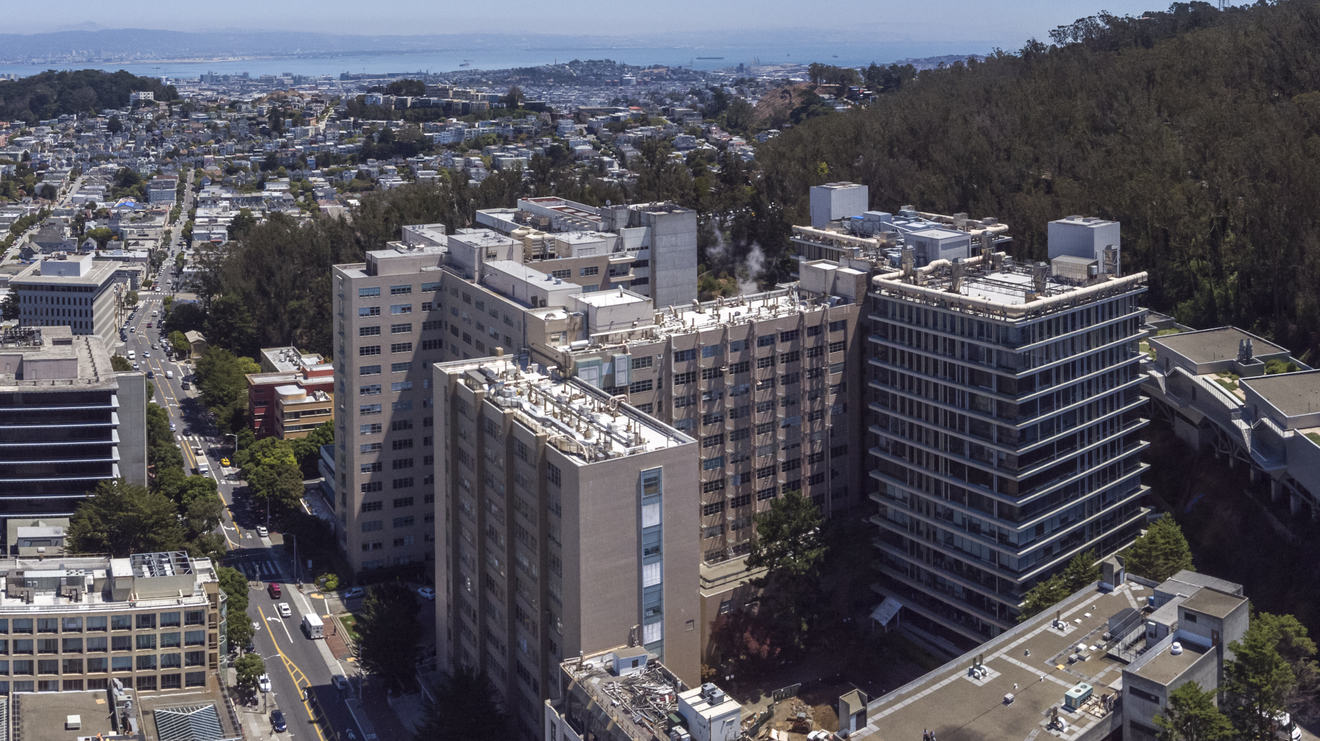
xmin=867 ymin=217 xmax=1147 ymax=650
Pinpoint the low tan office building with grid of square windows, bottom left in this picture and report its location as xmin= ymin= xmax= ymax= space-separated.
xmin=0 ymin=552 xmax=227 ymax=693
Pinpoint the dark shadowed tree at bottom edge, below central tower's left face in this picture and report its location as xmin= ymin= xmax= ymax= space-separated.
xmin=413 ymin=666 xmax=513 ymax=741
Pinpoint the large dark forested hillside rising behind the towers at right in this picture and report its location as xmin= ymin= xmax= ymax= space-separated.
xmin=756 ymin=0 xmax=1320 ymax=362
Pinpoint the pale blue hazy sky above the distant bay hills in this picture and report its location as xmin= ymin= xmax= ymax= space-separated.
xmin=15 ymin=0 xmax=1167 ymax=42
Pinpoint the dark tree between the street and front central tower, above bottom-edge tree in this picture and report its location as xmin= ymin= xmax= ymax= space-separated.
xmin=354 ymin=582 xmax=422 ymax=688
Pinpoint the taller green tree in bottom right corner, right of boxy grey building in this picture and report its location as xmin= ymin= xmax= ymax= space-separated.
xmin=1224 ymin=616 xmax=1296 ymax=738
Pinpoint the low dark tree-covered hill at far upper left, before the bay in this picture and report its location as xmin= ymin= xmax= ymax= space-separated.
xmin=0 ymin=70 xmax=178 ymax=124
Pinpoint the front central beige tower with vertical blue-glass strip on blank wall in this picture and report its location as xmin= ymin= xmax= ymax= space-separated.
xmin=433 ymin=357 xmax=701 ymax=738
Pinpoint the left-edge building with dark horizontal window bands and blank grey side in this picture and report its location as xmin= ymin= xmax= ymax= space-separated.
xmin=0 ymin=326 xmax=147 ymax=533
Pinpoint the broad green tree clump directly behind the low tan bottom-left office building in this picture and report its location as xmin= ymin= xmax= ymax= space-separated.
xmin=69 ymin=478 xmax=183 ymax=559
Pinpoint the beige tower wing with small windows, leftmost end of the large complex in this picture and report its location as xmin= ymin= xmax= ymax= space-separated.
xmin=331 ymin=243 xmax=445 ymax=571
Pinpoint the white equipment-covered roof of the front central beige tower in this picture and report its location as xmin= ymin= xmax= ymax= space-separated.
xmin=436 ymin=358 xmax=694 ymax=464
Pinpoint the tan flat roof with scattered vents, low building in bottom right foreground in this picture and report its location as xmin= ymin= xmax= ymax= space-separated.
xmin=854 ymin=582 xmax=1150 ymax=741
